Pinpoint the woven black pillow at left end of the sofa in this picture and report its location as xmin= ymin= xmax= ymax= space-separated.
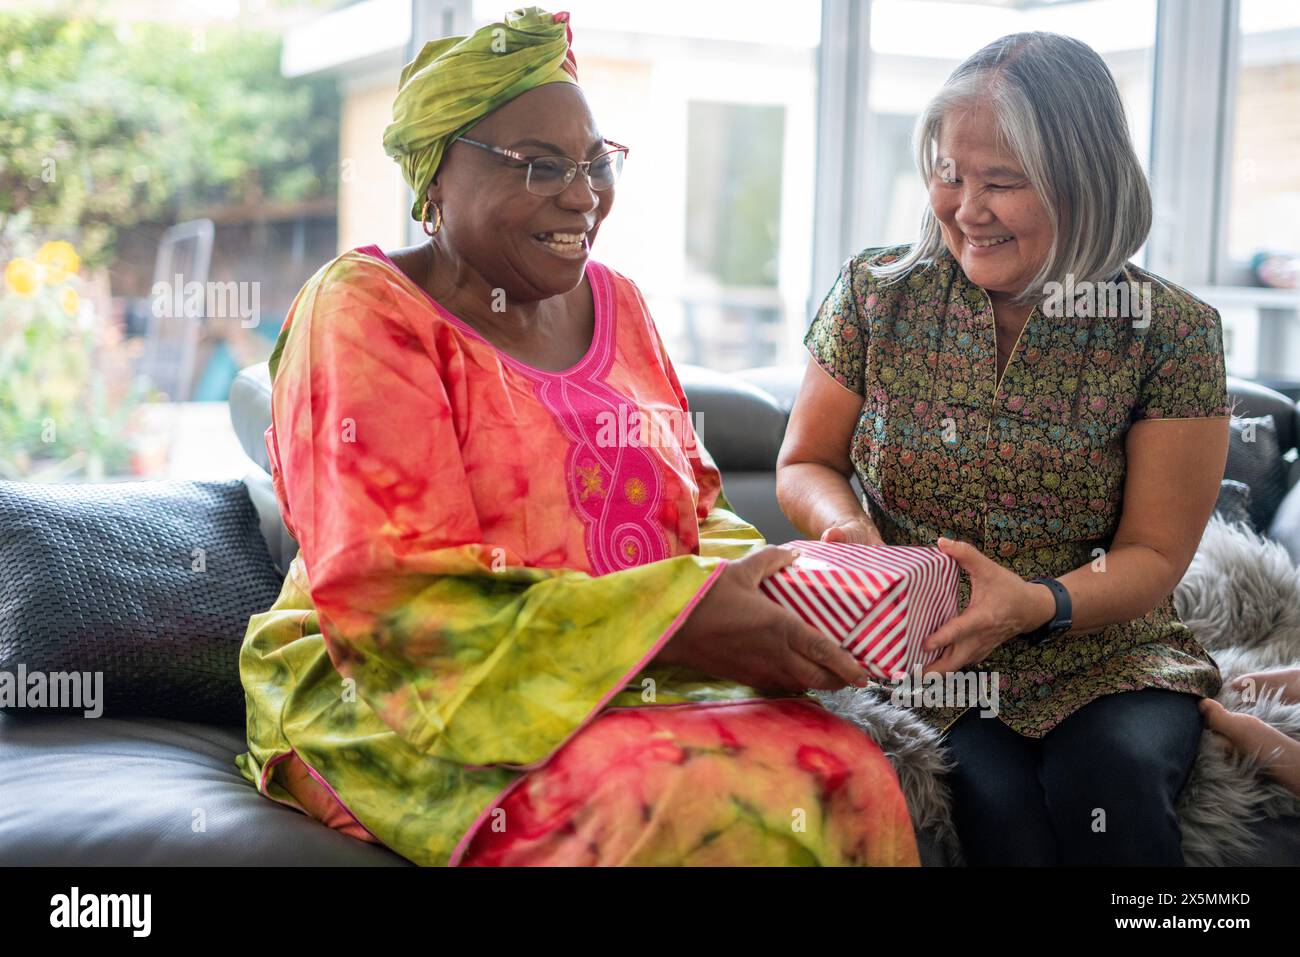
xmin=0 ymin=481 xmax=283 ymax=724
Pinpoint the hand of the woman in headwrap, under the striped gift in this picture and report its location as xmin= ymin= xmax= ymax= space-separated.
xmin=655 ymin=545 xmax=871 ymax=692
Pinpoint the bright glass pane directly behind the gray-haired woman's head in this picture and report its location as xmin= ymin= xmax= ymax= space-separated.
xmin=867 ymin=0 xmax=1156 ymax=261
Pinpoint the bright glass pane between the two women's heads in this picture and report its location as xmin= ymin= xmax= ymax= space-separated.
xmin=473 ymin=0 xmax=822 ymax=369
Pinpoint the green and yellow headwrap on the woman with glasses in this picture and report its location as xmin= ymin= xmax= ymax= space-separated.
xmin=384 ymin=7 xmax=577 ymax=220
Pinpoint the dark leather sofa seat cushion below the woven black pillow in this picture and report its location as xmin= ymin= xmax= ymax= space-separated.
xmin=0 ymin=715 xmax=412 ymax=867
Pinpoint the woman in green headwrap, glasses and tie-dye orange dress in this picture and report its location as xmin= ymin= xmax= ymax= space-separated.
xmin=238 ymin=8 xmax=918 ymax=865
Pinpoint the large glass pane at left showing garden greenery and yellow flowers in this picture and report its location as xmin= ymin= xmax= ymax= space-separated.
xmin=0 ymin=0 xmax=335 ymax=481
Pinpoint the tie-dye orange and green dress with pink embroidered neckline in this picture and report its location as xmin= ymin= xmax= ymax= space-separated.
xmin=237 ymin=246 xmax=918 ymax=865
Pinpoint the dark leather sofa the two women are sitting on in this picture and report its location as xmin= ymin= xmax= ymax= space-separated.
xmin=0 ymin=365 xmax=1300 ymax=866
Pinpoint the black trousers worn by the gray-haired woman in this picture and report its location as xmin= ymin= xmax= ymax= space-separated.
xmin=944 ymin=688 xmax=1204 ymax=866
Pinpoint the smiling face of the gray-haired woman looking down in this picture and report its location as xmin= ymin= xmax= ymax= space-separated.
xmin=930 ymin=108 xmax=1052 ymax=296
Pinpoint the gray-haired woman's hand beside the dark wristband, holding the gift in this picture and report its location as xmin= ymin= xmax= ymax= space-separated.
xmin=922 ymin=538 xmax=1056 ymax=674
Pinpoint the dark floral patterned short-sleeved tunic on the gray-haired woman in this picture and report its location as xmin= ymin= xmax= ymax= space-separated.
xmin=803 ymin=246 xmax=1230 ymax=737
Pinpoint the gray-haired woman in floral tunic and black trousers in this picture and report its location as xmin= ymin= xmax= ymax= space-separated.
xmin=777 ymin=33 xmax=1230 ymax=865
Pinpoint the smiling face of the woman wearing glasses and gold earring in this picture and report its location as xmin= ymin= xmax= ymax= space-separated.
xmin=428 ymin=83 xmax=614 ymax=302
